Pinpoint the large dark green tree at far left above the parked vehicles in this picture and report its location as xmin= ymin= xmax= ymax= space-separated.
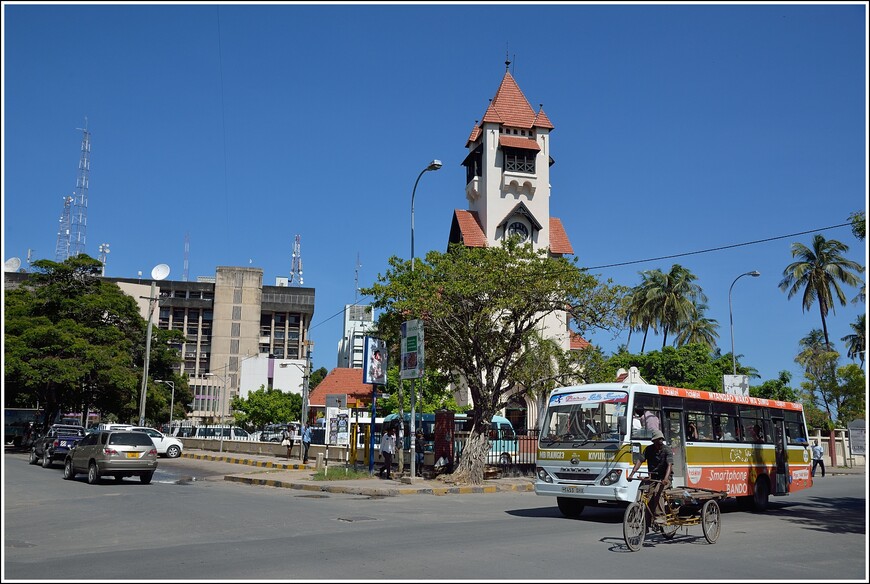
xmin=4 ymin=254 xmax=182 ymax=424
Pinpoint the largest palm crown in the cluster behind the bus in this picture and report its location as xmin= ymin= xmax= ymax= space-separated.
xmin=646 ymin=264 xmax=707 ymax=349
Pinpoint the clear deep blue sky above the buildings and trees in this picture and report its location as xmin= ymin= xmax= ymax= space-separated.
xmin=3 ymin=3 xmax=868 ymax=385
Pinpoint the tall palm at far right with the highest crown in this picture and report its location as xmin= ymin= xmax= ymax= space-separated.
xmin=779 ymin=234 xmax=863 ymax=346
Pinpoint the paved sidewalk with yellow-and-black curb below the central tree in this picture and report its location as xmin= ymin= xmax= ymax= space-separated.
xmin=181 ymin=449 xmax=535 ymax=497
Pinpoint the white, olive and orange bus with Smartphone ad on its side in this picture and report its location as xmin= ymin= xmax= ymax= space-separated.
xmin=535 ymin=383 xmax=812 ymax=517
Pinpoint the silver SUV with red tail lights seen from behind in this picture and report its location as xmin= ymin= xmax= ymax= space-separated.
xmin=63 ymin=430 xmax=157 ymax=485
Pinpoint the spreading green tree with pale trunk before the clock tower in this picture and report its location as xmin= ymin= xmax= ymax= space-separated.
xmin=362 ymin=239 xmax=623 ymax=484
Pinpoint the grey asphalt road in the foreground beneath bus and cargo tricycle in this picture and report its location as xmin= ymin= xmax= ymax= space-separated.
xmin=3 ymin=453 xmax=867 ymax=582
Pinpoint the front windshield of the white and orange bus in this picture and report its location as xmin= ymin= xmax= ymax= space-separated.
xmin=540 ymin=391 xmax=628 ymax=448
